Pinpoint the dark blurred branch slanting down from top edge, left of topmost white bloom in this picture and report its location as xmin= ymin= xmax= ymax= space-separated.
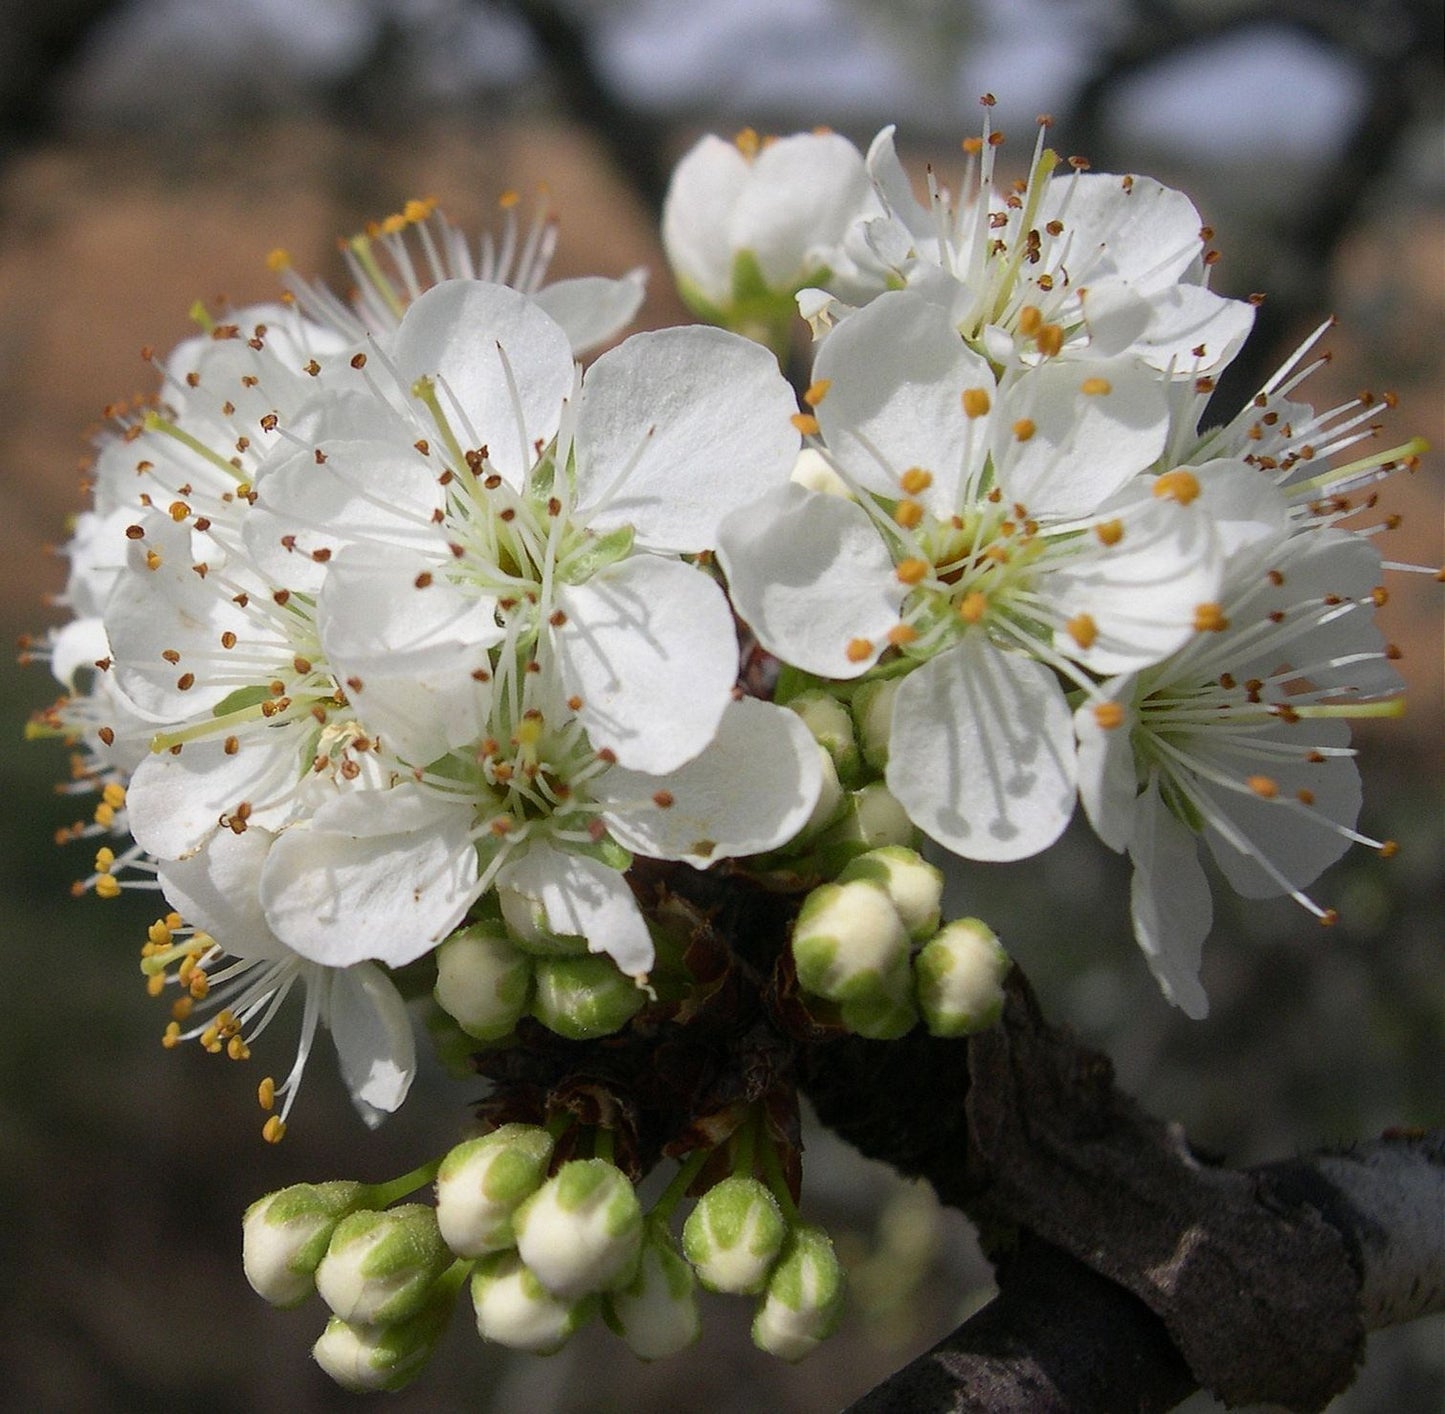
xmin=510 ymin=0 xmax=670 ymax=222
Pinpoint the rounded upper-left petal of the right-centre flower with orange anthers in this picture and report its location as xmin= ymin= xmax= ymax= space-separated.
xmin=814 ymin=290 xmax=996 ymax=516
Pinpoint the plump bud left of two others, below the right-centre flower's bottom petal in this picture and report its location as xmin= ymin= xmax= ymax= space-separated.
xmin=793 ymin=880 xmax=909 ymax=1002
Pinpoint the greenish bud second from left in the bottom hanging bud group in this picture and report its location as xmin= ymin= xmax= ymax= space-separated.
xmin=316 ymin=1203 xmax=452 ymax=1326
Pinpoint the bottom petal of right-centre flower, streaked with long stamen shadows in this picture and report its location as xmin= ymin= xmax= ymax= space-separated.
xmin=887 ymin=633 xmax=1075 ymax=859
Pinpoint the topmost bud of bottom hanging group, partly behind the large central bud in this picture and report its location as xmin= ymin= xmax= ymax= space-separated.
xmin=436 ymin=1124 xmax=552 ymax=1257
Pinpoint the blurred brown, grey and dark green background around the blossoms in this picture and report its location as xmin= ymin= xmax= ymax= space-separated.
xmin=0 ymin=0 xmax=1445 ymax=1414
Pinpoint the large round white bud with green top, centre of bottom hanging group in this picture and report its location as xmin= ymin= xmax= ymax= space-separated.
xmin=513 ymin=1158 xmax=642 ymax=1300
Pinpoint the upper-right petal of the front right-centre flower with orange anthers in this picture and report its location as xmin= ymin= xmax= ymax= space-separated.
xmin=994 ymin=358 xmax=1169 ymax=516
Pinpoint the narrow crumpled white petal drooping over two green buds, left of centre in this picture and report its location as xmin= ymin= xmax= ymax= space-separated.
xmin=497 ymin=843 xmax=653 ymax=976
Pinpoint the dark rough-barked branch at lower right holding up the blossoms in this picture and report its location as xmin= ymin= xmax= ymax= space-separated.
xmin=805 ymin=973 xmax=1445 ymax=1414
